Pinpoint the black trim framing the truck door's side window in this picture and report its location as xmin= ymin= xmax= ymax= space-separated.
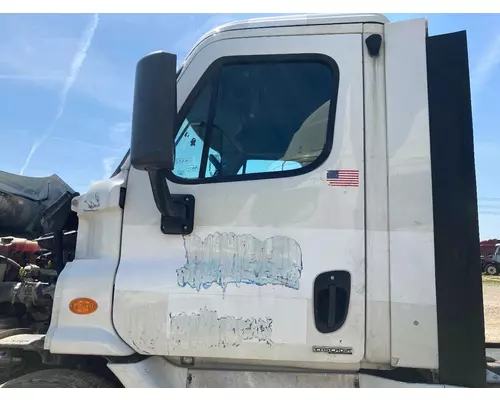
xmin=166 ymin=53 xmax=340 ymax=185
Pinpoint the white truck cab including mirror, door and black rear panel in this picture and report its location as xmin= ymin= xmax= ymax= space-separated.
xmin=0 ymin=14 xmax=485 ymax=387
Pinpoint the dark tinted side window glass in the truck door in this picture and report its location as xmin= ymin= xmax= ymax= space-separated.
xmin=173 ymin=56 xmax=338 ymax=182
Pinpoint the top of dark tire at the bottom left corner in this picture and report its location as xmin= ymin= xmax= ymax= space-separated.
xmin=0 ymin=369 xmax=115 ymax=389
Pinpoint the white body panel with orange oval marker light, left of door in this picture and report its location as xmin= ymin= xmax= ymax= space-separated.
xmin=45 ymin=170 xmax=134 ymax=356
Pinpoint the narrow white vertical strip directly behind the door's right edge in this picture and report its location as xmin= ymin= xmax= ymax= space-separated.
xmin=363 ymin=24 xmax=391 ymax=365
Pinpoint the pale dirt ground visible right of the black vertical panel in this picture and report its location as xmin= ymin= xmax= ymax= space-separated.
xmin=483 ymin=276 xmax=500 ymax=342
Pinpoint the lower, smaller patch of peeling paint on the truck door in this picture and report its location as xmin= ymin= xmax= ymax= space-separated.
xmin=170 ymin=308 xmax=273 ymax=347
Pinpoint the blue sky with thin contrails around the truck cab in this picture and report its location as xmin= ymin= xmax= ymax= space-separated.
xmin=0 ymin=14 xmax=500 ymax=239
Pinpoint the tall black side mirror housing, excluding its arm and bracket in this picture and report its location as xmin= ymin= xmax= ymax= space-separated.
xmin=130 ymin=51 xmax=177 ymax=171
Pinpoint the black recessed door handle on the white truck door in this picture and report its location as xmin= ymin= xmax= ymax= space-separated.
xmin=314 ymin=271 xmax=351 ymax=333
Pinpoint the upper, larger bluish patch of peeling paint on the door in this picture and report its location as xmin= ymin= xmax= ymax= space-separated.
xmin=177 ymin=233 xmax=302 ymax=291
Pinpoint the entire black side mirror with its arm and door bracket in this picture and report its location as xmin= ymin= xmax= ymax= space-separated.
xmin=130 ymin=51 xmax=195 ymax=235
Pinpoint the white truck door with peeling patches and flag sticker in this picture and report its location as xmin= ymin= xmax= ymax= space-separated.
xmin=113 ymin=27 xmax=365 ymax=369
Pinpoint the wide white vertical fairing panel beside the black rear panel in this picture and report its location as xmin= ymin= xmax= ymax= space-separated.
xmin=386 ymin=19 xmax=438 ymax=368
